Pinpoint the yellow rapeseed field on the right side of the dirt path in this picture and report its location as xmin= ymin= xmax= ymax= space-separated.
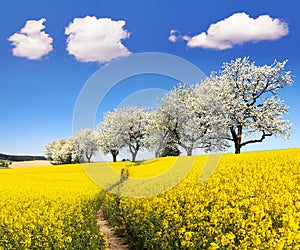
xmin=104 ymin=149 xmax=300 ymax=249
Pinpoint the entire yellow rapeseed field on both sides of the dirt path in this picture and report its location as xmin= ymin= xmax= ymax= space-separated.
xmin=0 ymin=149 xmax=300 ymax=249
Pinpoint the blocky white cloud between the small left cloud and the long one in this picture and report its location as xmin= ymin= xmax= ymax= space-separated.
xmin=65 ymin=16 xmax=131 ymax=63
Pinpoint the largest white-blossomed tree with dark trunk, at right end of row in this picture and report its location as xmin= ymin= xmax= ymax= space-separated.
xmin=210 ymin=57 xmax=292 ymax=154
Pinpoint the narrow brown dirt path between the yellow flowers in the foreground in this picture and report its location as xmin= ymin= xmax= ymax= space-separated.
xmin=98 ymin=207 xmax=130 ymax=250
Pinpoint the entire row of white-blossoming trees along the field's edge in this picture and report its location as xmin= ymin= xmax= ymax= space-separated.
xmin=45 ymin=57 xmax=292 ymax=163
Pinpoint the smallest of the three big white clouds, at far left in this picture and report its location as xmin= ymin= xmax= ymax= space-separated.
xmin=8 ymin=18 xmax=53 ymax=60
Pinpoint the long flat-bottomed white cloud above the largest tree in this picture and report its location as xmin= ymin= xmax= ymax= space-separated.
xmin=179 ymin=13 xmax=289 ymax=50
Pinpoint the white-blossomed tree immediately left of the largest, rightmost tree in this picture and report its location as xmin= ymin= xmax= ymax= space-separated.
xmin=149 ymin=84 xmax=227 ymax=155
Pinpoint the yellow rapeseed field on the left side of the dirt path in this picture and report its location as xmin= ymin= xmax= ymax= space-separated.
xmin=0 ymin=165 xmax=104 ymax=250
